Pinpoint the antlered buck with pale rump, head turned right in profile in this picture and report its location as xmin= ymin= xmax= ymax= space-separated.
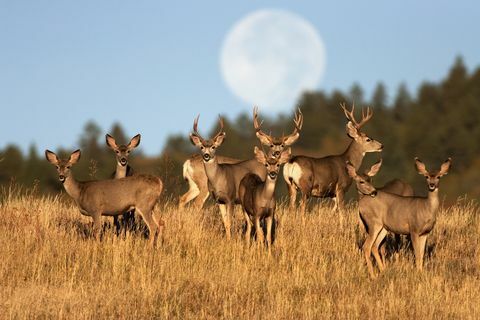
xmin=283 ymin=104 xmax=383 ymax=218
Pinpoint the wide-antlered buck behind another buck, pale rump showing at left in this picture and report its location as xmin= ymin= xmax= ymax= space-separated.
xmin=178 ymin=107 xmax=303 ymax=209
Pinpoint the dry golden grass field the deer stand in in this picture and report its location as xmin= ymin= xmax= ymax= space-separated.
xmin=0 ymin=186 xmax=480 ymax=319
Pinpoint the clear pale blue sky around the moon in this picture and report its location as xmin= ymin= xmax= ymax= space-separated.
xmin=0 ymin=0 xmax=480 ymax=154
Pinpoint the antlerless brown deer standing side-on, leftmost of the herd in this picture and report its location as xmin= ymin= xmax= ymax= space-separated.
xmin=45 ymin=150 xmax=165 ymax=247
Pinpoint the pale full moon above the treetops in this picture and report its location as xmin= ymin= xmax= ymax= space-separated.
xmin=220 ymin=10 xmax=326 ymax=111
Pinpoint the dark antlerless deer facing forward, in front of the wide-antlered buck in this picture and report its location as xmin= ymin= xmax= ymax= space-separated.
xmin=239 ymin=147 xmax=291 ymax=248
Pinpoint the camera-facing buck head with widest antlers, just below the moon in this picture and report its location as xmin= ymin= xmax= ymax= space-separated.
xmin=253 ymin=107 xmax=303 ymax=158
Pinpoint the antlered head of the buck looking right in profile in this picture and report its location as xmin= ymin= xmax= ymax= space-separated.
xmin=340 ymin=103 xmax=383 ymax=153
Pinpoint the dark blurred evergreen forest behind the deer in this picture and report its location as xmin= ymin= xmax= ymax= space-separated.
xmin=0 ymin=58 xmax=480 ymax=202
